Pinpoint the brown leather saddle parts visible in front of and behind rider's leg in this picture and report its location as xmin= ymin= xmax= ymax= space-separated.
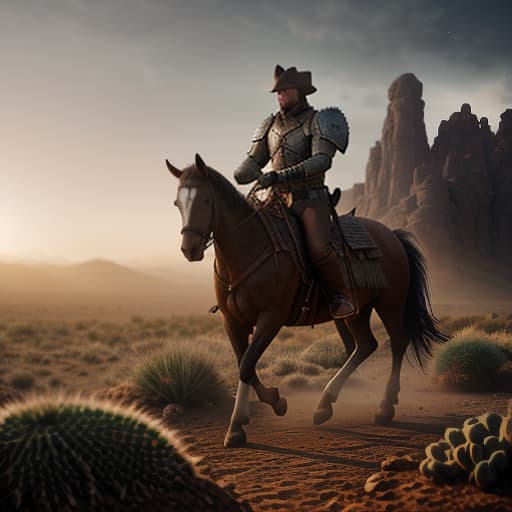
xmin=247 ymin=187 xmax=388 ymax=325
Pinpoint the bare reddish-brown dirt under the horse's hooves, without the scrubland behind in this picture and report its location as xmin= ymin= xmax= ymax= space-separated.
xmin=169 ymin=354 xmax=512 ymax=512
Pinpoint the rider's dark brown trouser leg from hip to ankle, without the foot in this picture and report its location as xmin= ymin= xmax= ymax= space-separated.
xmin=290 ymin=197 xmax=345 ymax=292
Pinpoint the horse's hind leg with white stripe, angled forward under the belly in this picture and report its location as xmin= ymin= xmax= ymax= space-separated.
xmin=313 ymin=305 xmax=378 ymax=425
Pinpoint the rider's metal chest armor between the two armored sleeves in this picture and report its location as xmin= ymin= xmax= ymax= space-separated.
xmin=267 ymin=108 xmax=315 ymax=171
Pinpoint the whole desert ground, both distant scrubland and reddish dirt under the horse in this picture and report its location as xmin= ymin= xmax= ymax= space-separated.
xmin=0 ymin=298 xmax=512 ymax=511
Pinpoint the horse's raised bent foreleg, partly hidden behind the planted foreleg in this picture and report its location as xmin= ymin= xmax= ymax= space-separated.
xmin=224 ymin=319 xmax=288 ymax=416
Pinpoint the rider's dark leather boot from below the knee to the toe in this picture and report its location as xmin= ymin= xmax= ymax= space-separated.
xmin=316 ymin=250 xmax=356 ymax=318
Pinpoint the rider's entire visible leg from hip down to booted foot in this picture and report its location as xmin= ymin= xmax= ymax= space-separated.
xmin=294 ymin=198 xmax=355 ymax=318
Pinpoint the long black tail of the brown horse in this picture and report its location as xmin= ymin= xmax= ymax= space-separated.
xmin=394 ymin=229 xmax=448 ymax=369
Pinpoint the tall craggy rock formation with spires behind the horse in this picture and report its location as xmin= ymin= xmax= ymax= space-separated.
xmin=340 ymin=74 xmax=512 ymax=300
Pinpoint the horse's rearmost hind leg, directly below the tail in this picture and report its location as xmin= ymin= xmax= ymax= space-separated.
xmin=375 ymin=308 xmax=409 ymax=425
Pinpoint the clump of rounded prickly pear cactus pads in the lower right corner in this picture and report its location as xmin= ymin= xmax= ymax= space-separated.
xmin=420 ymin=413 xmax=512 ymax=490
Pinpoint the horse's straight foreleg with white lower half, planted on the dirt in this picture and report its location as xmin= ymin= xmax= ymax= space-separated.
xmin=224 ymin=314 xmax=281 ymax=448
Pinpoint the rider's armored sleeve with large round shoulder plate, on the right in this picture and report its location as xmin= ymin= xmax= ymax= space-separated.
xmin=278 ymin=107 xmax=348 ymax=183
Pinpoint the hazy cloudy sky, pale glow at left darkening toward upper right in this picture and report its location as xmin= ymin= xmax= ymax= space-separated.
xmin=0 ymin=0 xmax=512 ymax=264
